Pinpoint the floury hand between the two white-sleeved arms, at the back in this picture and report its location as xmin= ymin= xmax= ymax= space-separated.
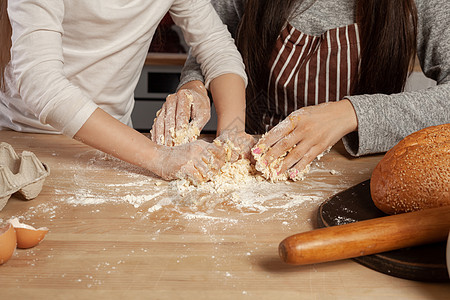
xmin=151 ymin=81 xmax=211 ymax=146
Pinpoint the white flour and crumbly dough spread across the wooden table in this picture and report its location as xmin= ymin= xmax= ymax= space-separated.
xmin=10 ymin=141 xmax=345 ymax=224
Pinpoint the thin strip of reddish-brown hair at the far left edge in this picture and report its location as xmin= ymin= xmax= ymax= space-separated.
xmin=0 ymin=0 xmax=11 ymax=89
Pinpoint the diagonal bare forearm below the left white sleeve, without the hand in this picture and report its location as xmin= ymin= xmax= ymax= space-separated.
xmin=74 ymin=109 xmax=161 ymax=175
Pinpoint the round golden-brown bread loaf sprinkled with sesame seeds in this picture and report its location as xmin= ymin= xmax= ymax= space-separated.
xmin=370 ymin=123 xmax=450 ymax=214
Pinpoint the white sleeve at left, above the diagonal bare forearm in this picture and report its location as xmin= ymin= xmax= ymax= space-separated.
xmin=8 ymin=0 xmax=97 ymax=136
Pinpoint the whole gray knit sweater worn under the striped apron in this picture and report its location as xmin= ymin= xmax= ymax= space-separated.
xmin=180 ymin=0 xmax=450 ymax=156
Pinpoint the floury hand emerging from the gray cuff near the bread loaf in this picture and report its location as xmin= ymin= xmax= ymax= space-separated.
xmin=253 ymin=100 xmax=358 ymax=179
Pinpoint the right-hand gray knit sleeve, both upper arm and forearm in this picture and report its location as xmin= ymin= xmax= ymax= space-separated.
xmin=343 ymin=0 xmax=450 ymax=156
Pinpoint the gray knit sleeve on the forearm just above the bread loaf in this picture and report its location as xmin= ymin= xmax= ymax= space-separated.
xmin=344 ymin=83 xmax=450 ymax=156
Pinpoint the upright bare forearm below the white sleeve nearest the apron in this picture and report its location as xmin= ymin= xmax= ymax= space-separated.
xmin=210 ymin=74 xmax=245 ymax=135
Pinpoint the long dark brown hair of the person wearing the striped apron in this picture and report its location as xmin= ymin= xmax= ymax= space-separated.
xmin=236 ymin=0 xmax=417 ymax=99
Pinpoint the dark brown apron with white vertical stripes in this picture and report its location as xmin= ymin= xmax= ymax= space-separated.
xmin=248 ymin=24 xmax=360 ymax=133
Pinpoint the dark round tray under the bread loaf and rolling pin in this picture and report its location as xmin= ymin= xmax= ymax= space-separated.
xmin=318 ymin=180 xmax=450 ymax=282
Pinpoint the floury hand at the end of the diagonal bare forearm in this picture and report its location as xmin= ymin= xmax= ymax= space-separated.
xmin=156 ymin=140 xmax=225 ymax=185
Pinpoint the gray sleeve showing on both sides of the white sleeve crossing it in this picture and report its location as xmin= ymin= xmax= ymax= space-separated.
xmin=179 ymin=0 xmax=244 ymax=86
